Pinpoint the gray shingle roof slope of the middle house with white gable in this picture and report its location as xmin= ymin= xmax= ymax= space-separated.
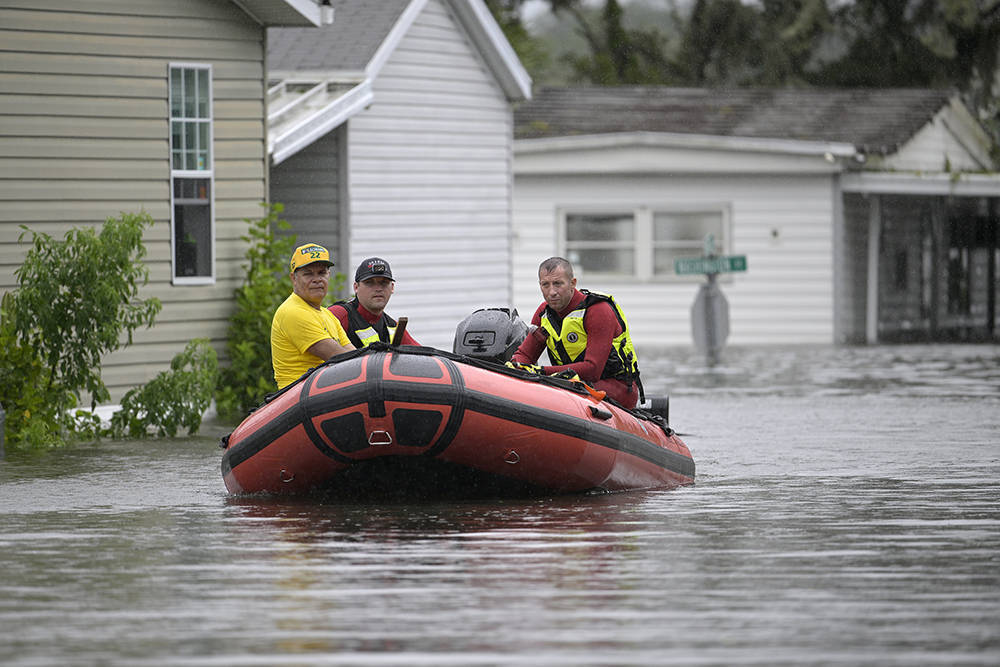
xmin=267 ymin=0 xmax=410 ymax=71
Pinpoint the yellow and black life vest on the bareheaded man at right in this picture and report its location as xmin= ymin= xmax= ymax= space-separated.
xmin=541 ymin=290 xmax=645 ymax=400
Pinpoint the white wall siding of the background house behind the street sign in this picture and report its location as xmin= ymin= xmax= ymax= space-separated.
xmin=514 ymin=174 xmax=834 ymax=348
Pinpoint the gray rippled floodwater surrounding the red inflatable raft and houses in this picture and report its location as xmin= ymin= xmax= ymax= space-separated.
xmin=0 ymin=345 xmax=1000 ymax=665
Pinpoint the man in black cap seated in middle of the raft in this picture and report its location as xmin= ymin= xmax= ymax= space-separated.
xmin=330 ymin=257 xmax=420 ymax=349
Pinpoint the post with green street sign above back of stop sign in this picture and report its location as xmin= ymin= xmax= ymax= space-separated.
xmin=674 ymin=234 xmax=747 ymax=364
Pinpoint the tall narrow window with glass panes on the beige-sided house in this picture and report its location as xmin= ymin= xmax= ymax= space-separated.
xmin=170 ymin=64 xmax=215 ymax=284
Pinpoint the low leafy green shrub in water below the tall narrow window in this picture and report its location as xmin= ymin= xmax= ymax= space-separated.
xmin=110 ymin=338 xmax=219 ymax=438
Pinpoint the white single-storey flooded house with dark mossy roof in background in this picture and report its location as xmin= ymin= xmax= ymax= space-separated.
xmin=514 ymin=87 xmax=1000 ymax=346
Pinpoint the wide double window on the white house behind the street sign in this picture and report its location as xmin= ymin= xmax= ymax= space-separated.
xmin=562 ymin=205 xmax=729 ymax=280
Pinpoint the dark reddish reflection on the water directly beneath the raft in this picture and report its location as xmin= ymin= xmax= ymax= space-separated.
xmin=226 ymin=491 xmax=652 ymax=577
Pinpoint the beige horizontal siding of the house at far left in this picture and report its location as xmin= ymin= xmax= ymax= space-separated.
xmin=0 ymin=0 xmax=267 ymax=400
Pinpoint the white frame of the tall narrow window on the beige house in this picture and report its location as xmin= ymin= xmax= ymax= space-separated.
xmin=167 ymin=62 xmax=218 ymax=285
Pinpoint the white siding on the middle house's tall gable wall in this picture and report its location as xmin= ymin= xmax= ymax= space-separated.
xmin=348 ymin=0 xmax=512 ymax=349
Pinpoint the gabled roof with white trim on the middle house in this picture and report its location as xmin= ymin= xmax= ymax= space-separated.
xmin=267 ymin=0 xmax=531 ymax=164
